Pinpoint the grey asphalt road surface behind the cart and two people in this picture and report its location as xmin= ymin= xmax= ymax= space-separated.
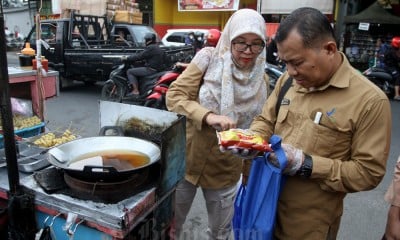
xmin=8 ymin=50 xmax=400 ymax=240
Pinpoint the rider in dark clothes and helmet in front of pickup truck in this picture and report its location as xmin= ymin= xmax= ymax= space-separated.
xmin=123 ymin=33 xmax=165 ymax=97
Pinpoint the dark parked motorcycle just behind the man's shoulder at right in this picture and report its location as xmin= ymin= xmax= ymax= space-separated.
xmin=363 ymin=67 xmax=399 ymax=99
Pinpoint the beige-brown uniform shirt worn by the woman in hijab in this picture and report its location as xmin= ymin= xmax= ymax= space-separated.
xmin=167 ymin=64 xmax=267 ymax=189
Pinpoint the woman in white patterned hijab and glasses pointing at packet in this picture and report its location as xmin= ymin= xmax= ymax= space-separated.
xmin=167 ymin=9 xmax=268 ymax=239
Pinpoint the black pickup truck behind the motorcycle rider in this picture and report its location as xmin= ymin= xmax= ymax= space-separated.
xmin=25 ymin=14 xmax=194 ymax=88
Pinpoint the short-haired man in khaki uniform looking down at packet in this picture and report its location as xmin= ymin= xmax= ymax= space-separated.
xmin=250 ymin=8 xmax=391 ymax=240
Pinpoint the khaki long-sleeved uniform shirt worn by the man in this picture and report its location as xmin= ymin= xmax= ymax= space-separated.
xmin=251 ymin=54 xmax=391 ymax=240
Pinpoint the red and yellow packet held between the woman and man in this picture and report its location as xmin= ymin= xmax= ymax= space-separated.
xmin=217 ymin=128 xmax=272 ymax=152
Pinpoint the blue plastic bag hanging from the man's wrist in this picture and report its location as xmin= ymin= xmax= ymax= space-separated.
xmin=232 ymin=135 xmax=287 ymax=240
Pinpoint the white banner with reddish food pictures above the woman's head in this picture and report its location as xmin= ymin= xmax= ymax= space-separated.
xmin=178 ymin=0 xmax=239 ymax=11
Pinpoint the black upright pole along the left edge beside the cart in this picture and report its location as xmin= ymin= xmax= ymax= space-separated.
xmin=0 ymin=5 xmax=37 ymax=240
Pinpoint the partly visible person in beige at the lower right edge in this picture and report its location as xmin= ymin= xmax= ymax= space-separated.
xmin=382 ymin=156 xmax=400 ymax=240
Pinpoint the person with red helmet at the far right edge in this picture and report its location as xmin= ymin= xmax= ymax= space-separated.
xmin=384 ymin=36 xmax=400 ymax=101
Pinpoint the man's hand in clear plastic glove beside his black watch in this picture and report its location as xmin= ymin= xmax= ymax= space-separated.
xmin=268 ymin=144 xmax=304 ymax=176
